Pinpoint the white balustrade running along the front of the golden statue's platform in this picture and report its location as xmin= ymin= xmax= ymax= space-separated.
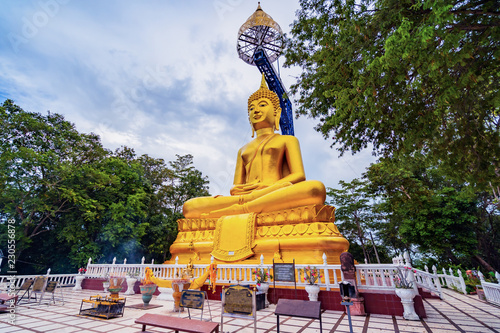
xmin=85 ymin=254 xmax=397 ymax=291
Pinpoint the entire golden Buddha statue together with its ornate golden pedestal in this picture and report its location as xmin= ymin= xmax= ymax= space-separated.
xmin=170 ymin=77 xmax=349 ymax=264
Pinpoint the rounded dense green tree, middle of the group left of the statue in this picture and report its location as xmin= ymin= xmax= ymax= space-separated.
xmin=59 ymin=147 xmax=149 ymax=264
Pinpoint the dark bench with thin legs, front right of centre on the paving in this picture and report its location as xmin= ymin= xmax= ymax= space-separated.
xmin=274 ymin=298 xmax=323 ymax=333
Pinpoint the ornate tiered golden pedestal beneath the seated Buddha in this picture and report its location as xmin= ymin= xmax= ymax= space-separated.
xmin=165 ymin=205 xmax=349 ymax=265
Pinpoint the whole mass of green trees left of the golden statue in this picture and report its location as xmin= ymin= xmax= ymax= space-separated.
xmin=0 ymin=100 xmax=208 ymax=272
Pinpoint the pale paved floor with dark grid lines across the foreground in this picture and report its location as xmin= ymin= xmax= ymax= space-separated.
xmin=0 ymin=288 xmax=500 ymax=333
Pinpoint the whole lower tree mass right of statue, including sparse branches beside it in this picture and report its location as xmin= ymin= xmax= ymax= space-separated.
xmin=328 ymin=155 xmax=500 ymax=271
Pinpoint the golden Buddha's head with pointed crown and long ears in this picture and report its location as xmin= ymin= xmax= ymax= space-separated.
xmin=248 ymin=75 xmax=281 ymax=137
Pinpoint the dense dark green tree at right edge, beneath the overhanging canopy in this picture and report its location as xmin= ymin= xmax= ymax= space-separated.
xmin=366 ymin=157 xmax=500 ymax=270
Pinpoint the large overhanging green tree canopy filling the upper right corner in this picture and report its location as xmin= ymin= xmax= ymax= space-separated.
xmin=286 ymin=0 xmax=500 ymax=190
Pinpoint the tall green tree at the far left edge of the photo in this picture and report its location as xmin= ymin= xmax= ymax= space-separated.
xmin=0 ymin=100 xmax=106 ymax=268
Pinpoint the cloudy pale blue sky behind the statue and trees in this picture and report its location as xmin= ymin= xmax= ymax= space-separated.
xmin=0 ymin=0 xmax=374 ymax=195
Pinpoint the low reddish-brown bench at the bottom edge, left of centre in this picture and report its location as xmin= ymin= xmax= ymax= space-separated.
xmin=135 ymin=313 xmax=219 ymax=333
